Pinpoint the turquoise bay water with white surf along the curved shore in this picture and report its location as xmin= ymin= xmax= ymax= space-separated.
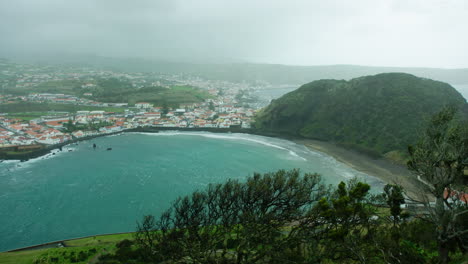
xmin=0 ymin=132 xmax=381 ymax=251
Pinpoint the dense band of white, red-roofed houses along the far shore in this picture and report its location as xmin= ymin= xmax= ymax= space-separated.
xmin=0 ymin=89 xmax=255 ymax=147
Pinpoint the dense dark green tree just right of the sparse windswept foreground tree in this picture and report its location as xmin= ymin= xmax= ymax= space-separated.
xmin=306 ymin=180 xmax=379 ymax=263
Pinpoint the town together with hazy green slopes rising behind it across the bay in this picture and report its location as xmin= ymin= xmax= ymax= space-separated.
xmin=0 ymin=59 xmax=266 ymax=150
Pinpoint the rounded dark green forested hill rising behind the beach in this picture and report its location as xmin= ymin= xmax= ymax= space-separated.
xmin=255 ymin=73 xmax=467 ymax=159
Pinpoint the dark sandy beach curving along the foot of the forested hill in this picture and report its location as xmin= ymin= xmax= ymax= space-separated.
xmin=294 ymin=139 xmax=420 ymax=197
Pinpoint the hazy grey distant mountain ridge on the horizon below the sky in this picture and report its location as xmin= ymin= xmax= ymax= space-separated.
xmin=2 ymin=55 xmax=468 ymax=84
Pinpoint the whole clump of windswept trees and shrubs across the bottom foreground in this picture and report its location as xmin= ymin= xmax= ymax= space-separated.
xmin=100 ymin=170 xmax=454 ymax=264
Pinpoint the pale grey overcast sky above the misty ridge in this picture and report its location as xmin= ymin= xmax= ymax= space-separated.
xmin=0 ymin=0 xmax=468 ymax=68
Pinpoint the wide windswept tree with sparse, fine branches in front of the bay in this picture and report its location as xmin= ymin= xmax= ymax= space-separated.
xmin=136 ymin=170 xmax=325 ymax=263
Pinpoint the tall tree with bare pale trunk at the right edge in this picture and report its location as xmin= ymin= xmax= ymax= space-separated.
xmin=408 ymin=108 xmax=468 ymax=263
